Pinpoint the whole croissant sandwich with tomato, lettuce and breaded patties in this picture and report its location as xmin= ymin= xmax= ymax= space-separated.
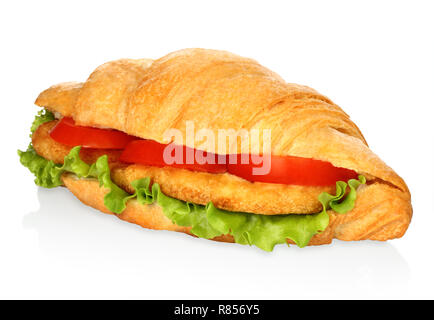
xmin=18 ymin=49 xmax=412 ymax=251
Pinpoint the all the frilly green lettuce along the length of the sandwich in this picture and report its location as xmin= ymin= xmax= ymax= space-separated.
xmin=18 ymin=111 xmax=366 ymax=251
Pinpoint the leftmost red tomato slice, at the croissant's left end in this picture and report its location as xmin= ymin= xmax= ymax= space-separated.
xmin=50 ymin=117 xmax=137 ymax=149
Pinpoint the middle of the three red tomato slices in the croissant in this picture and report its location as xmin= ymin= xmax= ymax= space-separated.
xmin=120 ymin=140 xmax=226 ymax=173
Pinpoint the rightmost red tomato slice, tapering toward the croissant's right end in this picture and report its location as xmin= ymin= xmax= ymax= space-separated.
xmin=228 ymin=155 xmax=357 ymax=186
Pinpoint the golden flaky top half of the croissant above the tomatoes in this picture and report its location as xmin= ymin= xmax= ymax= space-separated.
xmin=35 ymin=49 xmax=408 ymax=193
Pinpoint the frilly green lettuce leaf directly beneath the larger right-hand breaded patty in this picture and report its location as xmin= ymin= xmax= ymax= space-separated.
xmin=132 ymin=176 xmax=365 ymax=251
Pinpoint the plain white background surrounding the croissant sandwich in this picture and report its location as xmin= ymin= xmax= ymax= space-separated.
xmin=0 ymin=0 xmax=434 ymax=299
